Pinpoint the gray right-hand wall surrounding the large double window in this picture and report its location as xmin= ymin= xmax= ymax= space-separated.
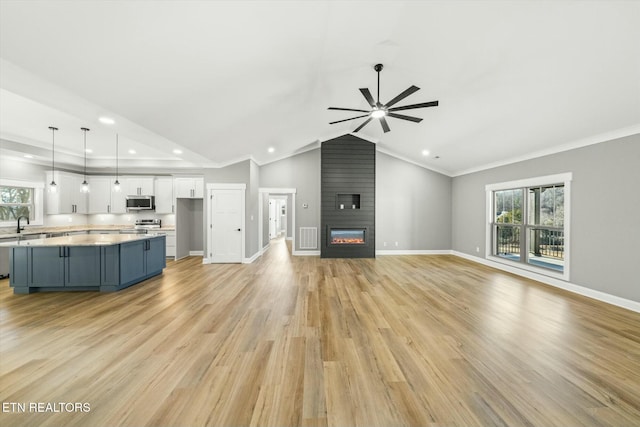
xmin=452 ymin=135 xmax=640 ymax=301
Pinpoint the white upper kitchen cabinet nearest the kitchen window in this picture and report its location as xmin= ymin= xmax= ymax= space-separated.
xmin=46 ymin=171 xmax=87 ymax=215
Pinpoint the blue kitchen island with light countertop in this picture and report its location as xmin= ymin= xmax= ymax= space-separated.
xmin=6 ymin=233 xmax=166 ymax=294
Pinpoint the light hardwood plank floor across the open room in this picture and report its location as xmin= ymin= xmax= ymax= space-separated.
xmin=0 ymin=241 xmax=640 ymax=427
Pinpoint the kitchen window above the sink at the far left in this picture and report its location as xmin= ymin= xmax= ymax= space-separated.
xmin=0 ymin=180 xmax=44 ymax=226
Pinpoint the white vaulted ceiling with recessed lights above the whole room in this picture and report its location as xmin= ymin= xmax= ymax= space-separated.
xmin=0 ymin=0 xmax=640 ymax=175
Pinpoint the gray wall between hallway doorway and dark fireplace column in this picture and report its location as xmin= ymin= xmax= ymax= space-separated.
xmin=260 ymin=149 xmax=320 ymax=251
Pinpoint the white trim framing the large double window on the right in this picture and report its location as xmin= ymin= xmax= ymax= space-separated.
xmin=485 ymin=172 xmax=573 ymax=282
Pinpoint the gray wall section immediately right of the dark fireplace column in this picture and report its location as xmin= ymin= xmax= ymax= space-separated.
xmin=376 ymin=152 xmax=451 ymax=250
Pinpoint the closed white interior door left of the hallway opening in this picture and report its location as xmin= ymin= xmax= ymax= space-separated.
xmin=211 ymin=190 xmax=244 ymax=263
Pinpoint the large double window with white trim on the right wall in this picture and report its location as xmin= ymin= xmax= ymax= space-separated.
xmin=486 ymin=174 xmax=571 ymax=280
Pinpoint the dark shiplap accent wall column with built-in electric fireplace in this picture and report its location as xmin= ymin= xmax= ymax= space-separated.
xmin=320 ymin=135 xmax=376 ymax=258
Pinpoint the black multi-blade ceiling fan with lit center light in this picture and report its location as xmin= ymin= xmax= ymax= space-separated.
xmin=329 ymin=64 xmax=438 ymax=133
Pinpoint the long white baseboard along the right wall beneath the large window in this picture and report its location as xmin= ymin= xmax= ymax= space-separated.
xmin=451 ymin=251 xmax=640 ymax=313
